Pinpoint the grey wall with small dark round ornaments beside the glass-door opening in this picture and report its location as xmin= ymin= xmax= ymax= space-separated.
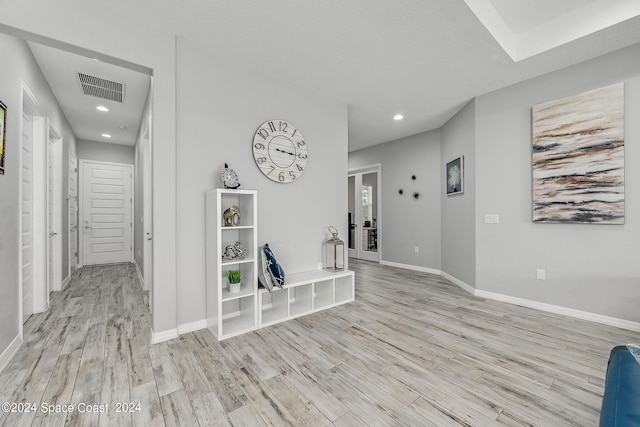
xmin=342 ymin=130 xmax=441 ymax=270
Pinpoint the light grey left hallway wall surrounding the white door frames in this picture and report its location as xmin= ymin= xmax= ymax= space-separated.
xmin=0 ymin=34 xmax=76 ymax=360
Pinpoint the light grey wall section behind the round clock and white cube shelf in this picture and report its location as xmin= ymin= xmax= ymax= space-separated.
xmin=177 ymin=39 xmax=347 ymax=325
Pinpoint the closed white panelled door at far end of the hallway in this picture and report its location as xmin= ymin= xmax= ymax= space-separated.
xmin=80 ymin=160 xmax=133 ymax=265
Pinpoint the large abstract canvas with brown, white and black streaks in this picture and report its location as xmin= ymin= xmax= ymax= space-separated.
xmin=532 ymin=83 xmax=624 ymax=224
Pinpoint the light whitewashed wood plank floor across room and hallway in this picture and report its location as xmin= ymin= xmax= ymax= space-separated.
xmin=0 ymin=260 xmax=640 ymax=427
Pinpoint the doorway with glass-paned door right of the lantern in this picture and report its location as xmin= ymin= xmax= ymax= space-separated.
xmin=347 ymin=164 xmax=382 ymax=262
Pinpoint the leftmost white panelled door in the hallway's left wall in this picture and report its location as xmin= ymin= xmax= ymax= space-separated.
xmin=21 ymin=114 xmax=33 ymax=321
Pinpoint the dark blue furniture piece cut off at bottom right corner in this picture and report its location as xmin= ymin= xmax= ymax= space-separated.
xmin=600 ymin=345 xmax=640 ymax=427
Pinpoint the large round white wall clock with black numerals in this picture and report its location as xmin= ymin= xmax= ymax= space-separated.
xmin=253 ymin=120 xmax=308 ymax=184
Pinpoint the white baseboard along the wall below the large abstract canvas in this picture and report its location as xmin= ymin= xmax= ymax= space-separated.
xmin=475 ymin=289 xmax=640 ymax=332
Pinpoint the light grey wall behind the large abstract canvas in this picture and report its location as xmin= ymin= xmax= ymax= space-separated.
xmin=476 ymin=45 xmax=640 ymax=322
